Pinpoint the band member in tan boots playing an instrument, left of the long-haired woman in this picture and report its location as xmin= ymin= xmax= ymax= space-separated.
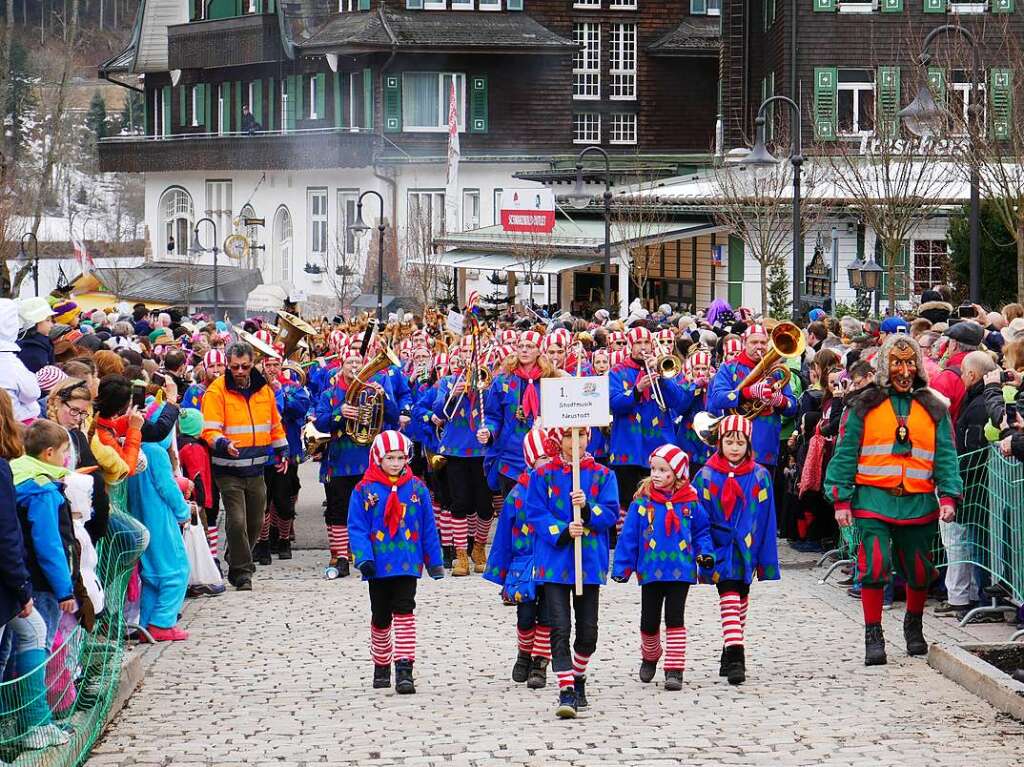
xmin=434 ymin=336 xmax=494 ymax=577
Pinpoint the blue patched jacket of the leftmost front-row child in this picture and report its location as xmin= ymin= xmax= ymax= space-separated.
xmin=348 ymin=477 xmax=442 ymax=581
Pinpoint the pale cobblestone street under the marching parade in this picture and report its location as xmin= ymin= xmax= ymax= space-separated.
xmin=89 ymin=466 xmax=1024 ymax=767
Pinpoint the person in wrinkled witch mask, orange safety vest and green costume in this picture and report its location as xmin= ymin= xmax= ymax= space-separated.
xmin=825 ymin=334 xmax=964 ymax=666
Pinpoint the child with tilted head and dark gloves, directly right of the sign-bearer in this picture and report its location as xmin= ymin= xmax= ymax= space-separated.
xmin=611 ymin=444 xmax=715 ymax=691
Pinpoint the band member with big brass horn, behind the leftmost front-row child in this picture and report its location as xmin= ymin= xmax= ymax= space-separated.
xmin=314 ymin=349 xmax=397 ymax=580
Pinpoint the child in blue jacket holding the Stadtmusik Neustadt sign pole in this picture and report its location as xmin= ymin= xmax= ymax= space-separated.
xmin=526 ymin=429 xmax=618 ymax=719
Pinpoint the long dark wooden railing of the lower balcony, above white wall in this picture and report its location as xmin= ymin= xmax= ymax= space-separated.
xmin=98 ymin=128 xmax=376 ymax=173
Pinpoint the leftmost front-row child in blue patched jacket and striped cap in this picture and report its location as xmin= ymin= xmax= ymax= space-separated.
xmin=348 ymin=431 xmax=444 ymax=695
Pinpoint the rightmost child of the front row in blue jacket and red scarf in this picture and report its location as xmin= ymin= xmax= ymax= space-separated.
xmin=693 ymin=415 xmax=779 ymax=684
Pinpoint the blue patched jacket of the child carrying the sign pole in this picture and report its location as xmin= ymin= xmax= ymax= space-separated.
xmin=526 ymin=460 xmax=618 ymax=586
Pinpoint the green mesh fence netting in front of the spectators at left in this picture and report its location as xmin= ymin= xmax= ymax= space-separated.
xmin=0 ymin=499 xmax=148 ymax=767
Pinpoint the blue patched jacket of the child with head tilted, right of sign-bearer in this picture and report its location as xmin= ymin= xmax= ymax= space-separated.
xmin=611 ymin=487 xmax=715 ymax=586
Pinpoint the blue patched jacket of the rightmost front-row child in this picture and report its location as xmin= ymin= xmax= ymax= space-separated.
xmin=693 ymin=462 xmax=779 ymax=584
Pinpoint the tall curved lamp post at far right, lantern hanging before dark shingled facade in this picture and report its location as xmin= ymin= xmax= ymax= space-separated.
xmin=899 ymin=24 xmax=982 ymax=303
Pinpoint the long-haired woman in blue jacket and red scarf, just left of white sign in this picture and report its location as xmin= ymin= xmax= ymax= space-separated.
xmin=477 ymin=331 xmax=560 ymax=496
